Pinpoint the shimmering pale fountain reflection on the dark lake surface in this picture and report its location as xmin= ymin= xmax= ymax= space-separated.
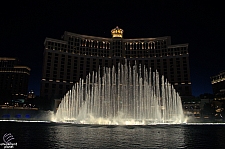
xmin=51 ymin=125 xmax=185 ymax=148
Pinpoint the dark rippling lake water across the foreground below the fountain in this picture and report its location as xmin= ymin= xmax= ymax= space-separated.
xmin=0 ymin=121 xmax=225 ymax=149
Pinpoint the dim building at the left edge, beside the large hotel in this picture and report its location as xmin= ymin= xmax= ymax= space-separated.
xmin=0 ymin=57 xmax=30 ymax=104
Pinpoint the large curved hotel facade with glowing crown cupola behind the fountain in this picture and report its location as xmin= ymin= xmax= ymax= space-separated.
xmin=41 ymin=27 xmax=192 ymax=99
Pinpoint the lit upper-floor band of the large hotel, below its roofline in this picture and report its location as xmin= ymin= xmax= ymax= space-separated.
xmin=46 ymin=37 xmax=188 ymax=58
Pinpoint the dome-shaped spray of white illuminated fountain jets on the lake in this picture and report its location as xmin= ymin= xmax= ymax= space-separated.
xmin=55 ymin=62 xmax=183 ymax=125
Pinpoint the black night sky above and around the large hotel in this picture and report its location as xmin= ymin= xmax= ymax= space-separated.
xmin=0 ymin=0 xmax=225 ymax=96
